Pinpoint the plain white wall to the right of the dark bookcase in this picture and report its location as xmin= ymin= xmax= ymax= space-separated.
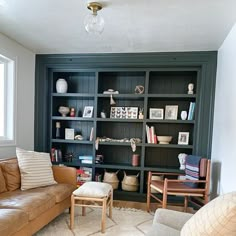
xmin=212 ymin=24 xmax=236 ymax=194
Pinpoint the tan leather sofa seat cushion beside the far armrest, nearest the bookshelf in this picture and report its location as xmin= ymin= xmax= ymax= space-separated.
xmin=33 ymin=184 xmax=75 ymax=203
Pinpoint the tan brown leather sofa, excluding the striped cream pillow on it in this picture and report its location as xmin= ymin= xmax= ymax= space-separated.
xmin=0 ymin=158 xmax=76 ymax=236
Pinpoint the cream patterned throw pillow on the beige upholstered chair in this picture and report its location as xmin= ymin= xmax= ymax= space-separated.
xmin=180 ymin=192 xmax=236 ymax=236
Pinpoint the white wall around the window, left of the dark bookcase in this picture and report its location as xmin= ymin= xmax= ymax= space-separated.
xmin=0 ymin=33 xmax=35 ymax=158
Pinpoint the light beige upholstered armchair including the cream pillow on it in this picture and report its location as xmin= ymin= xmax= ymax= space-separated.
xmin=147 ymin=191 xmax=236 ymax=236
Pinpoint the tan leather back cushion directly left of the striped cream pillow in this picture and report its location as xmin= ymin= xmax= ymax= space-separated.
xmin=1 ymin=159 xmax=21 ymax=191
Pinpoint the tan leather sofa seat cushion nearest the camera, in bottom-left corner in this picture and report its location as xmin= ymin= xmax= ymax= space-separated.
xmin=0 ymin=209 xmax=28 ymax=235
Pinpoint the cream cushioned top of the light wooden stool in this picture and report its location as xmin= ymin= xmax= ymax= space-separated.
xmin=73 ymin=181 xmax=112 ymax=198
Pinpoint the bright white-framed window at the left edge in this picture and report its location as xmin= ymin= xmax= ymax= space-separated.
xmin=0 ymin=55 xmax=15 ymax=145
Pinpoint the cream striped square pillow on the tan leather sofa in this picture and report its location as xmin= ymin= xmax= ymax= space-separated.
xmin=16 ymin=148 xmax=57 ymax=190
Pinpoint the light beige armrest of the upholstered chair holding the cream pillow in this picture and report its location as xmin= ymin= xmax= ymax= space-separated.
xmin=153 ymin=208 xmax=193 ymax=230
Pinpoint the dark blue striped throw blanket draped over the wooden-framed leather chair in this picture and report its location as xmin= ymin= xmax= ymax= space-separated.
xmin=185 ymin=155 xmax=201 ymax=188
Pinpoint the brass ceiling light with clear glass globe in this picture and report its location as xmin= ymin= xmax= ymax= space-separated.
xmin=84 ymin=2 xmax=104 ymax=34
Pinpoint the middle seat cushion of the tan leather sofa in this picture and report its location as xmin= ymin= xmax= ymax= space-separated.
xmin=0 ymin=189 xmax=56 ymax=220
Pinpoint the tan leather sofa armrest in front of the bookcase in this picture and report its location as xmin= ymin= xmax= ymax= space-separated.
xmin=52 ymin=166 xmax=77 ymax=187
